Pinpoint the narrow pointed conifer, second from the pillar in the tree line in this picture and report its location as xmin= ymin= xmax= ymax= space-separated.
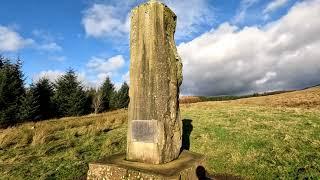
xmin=99 ymin=77 xmax=115 ymax=111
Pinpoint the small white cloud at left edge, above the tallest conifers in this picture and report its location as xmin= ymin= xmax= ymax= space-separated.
xmin=0 ymin=25 xmax=34 ymax=52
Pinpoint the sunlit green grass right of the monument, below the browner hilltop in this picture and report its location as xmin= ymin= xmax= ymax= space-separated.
xmin=182 ymin=103 xmax=320 ymax=179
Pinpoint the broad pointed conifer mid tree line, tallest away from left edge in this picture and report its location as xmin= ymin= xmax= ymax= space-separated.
xmin=53 ymin=70 xmax=89 ymax=116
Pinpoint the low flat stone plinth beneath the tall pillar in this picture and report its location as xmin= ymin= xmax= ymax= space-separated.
xmin=87 ymin=151 xmax=205 ymax=180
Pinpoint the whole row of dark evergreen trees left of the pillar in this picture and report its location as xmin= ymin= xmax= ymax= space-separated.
xmin=0 ymin=56 xmax=129 ymax=127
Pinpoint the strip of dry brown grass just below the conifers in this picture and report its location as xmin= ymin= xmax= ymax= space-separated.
xmin=0 ymin=110 xmax=127 ymax=149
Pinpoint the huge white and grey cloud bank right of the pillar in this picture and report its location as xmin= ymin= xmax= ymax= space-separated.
xmin=178 ymin=0 xmax=320 ymax=95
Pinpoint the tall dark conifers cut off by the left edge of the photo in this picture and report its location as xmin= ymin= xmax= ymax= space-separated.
xmin=0 ymin=56 xmax=25 ymax=126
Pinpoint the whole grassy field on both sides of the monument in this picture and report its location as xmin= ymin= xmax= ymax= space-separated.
xmin=0 ymin=88 xmax=320 ymax=179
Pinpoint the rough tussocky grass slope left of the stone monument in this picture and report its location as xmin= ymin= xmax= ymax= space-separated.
xmin=0 ymin=110 xmax=127 ymax=179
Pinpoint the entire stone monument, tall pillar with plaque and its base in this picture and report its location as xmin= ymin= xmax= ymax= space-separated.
xmin=88 ymin=0 xmax=204 ymax=179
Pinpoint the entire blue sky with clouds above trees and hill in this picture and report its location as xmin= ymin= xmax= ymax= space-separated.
xmin=0 ymin=0 xmax=320 ymax=96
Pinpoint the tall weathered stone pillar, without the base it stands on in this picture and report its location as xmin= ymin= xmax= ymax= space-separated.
xmin=127 ymin=1 xmax=182 ymax=164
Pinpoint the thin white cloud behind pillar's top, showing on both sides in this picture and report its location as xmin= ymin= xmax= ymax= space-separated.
xmin=82 ymin=0 xmax=215 ymax=38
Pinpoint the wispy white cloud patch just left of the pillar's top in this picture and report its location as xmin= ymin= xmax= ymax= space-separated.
xmin=82 ymin=4 xmax=129 ymax=38
